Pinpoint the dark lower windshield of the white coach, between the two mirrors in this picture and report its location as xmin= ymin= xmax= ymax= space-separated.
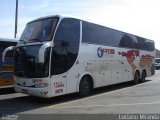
xmin=14 ymin=45 xmax=50 ymax=78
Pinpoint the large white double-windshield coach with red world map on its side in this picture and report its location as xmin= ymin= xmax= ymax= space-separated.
xmin=3 ymin=15 xmax=155 ymax=98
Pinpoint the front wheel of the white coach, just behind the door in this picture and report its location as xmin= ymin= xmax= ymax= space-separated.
xmin=79 ymin=76 xmax=92 ymax=97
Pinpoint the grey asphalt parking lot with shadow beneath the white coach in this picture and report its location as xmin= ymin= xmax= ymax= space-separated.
xmin=0 ymin=70 xmax=160 ymax=118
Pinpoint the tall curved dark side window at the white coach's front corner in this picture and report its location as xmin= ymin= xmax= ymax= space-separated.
xmin=51 ymin=18 xmax=80 ymax=75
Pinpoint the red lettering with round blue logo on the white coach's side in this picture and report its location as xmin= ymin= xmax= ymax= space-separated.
xmin=97 ymin=47 xmax=115 ymax=58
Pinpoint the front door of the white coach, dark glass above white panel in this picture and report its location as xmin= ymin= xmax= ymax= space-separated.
xmin=51 ymin=46 xmax=68 ymax=96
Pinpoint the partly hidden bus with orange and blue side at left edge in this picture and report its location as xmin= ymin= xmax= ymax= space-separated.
xmin=0 ymin=38 xmax=17 ymax=88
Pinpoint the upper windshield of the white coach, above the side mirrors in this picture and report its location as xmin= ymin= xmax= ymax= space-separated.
xmin=20 ymin=17 xmax=58 ymax=43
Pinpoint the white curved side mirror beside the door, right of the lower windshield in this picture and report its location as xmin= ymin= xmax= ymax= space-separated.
xmin=38 ymin=42 xmax=54 ymax=63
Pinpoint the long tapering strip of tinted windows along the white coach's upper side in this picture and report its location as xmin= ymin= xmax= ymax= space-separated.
xmin=82 ymin=21 xmax=155 ymax=51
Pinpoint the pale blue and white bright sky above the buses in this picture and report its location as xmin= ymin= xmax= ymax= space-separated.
xmin=0 ymin=0 xmax=160 ymax=50
